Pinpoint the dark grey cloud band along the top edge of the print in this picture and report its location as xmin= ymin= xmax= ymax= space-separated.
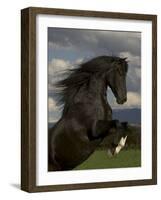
xmin=48 ymin=28 xmax=141 ymax=56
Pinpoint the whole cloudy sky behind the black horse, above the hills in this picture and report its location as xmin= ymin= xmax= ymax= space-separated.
xmin=48 ymin=28 xmax=141 ymax=122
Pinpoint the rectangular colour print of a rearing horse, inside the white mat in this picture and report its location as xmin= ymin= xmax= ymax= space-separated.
xmin=48 ymin=27 xmax=141 ymax=171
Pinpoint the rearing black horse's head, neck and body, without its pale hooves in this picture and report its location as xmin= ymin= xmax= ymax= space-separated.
xmin=48 ymin=56 xmax=128 ymax=171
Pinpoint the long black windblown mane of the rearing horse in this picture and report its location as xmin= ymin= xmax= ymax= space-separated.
xmin=55 ymin=56 xmax=127 ymax=105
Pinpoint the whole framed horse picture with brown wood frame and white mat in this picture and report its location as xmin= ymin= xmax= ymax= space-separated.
xmin=21 ymin=7 xmax=157 ymax=192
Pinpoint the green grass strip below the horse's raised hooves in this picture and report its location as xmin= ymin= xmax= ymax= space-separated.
xmin=75 ymin=149 xmax=141 ymax=170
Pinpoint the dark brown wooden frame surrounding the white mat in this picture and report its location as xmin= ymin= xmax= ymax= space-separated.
xmin=21 ymin=7 xmax=157 ymax=192
